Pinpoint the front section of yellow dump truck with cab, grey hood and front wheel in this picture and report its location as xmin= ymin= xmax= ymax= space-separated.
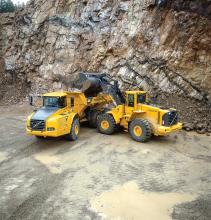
xmin=26 ymin=92 xmax=87 ymax=140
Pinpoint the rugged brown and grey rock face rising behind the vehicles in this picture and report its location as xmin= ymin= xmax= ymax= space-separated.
xmin=0 ymin=0 xmax=211 ymax=131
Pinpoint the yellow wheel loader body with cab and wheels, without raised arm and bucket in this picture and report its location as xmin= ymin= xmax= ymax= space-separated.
xmin=97 ymin=91 xmax=182 ymax=142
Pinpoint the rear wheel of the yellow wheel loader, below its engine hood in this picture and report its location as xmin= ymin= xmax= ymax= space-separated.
xmin=129 ymin=119 xmax=152 ymax=142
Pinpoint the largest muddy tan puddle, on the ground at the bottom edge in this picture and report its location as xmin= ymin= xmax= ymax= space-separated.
xmin=90 ymin=182 xmax=196 ymax=220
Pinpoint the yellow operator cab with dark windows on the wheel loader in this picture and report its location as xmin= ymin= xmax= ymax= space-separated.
xmin=125 ymin=91 xmax=147 ymax=114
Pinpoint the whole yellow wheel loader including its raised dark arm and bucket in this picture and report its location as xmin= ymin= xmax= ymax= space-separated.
xmin=74 ymin=74 xmax=182 ymax=142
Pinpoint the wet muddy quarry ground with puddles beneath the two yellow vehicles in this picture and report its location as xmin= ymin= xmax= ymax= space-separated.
xmin=0 ymin=106 xmax=211 ymax=220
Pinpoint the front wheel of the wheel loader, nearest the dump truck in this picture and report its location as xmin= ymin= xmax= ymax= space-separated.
xmin=97 ymin=113 xmax=116 ymax=135
